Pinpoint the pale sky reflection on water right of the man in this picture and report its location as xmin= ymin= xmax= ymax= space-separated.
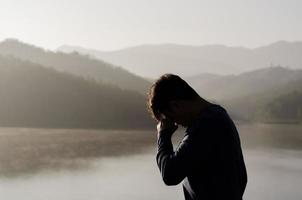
xmin=245 ymin=150 xmax=302 ymax=200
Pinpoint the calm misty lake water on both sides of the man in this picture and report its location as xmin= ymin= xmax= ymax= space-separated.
xmin=0 ymin=124 xmax=302 ymax=200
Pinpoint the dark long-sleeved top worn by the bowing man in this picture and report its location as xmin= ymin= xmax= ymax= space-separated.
xmin=156 ymin=104 xmax=247 ymax=200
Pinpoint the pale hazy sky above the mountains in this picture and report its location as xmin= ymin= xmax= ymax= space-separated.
xmin=0 ymin=0 xmax=302 ymax=51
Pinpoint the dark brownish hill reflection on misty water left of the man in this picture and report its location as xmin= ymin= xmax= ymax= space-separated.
xmin=0 ymin=128 xmax=156 ymax=177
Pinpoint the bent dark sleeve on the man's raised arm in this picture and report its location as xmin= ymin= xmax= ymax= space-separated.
xmin=156 ymin=126 xmax=209 ymax=185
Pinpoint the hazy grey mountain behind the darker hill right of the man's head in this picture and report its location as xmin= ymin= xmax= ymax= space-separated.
xmin=186 ymin=66 xmax=302 ymax=100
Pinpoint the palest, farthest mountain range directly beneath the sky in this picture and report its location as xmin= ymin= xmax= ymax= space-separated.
xmin=58 ymin=41 xmax=302 ymax=78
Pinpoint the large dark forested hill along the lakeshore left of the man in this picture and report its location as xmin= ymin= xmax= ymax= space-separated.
xmin=0 ymin=55 xmax=152 ymax=129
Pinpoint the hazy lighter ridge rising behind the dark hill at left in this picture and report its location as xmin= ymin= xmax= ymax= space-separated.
xmin=0 ymin=39 xmax=151 ymax=94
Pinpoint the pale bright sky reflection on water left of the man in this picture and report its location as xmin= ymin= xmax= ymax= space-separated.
xmin=0 ymin=155 xmax=181 ymax=200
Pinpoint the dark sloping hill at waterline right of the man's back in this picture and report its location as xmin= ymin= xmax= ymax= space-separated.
xmin=222 ymin=78 xmax=302 ymax=123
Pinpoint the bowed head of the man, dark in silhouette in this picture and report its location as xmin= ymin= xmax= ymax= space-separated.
xmin=147 ymin=74 xmax=206 ymax=126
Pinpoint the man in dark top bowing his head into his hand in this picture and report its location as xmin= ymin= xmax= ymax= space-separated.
xmin=148 ymin=74 xmax=247 ymax=200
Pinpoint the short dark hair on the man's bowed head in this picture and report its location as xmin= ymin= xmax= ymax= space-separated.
xmin=147 ymin=74 xmax=199 ymax=120
